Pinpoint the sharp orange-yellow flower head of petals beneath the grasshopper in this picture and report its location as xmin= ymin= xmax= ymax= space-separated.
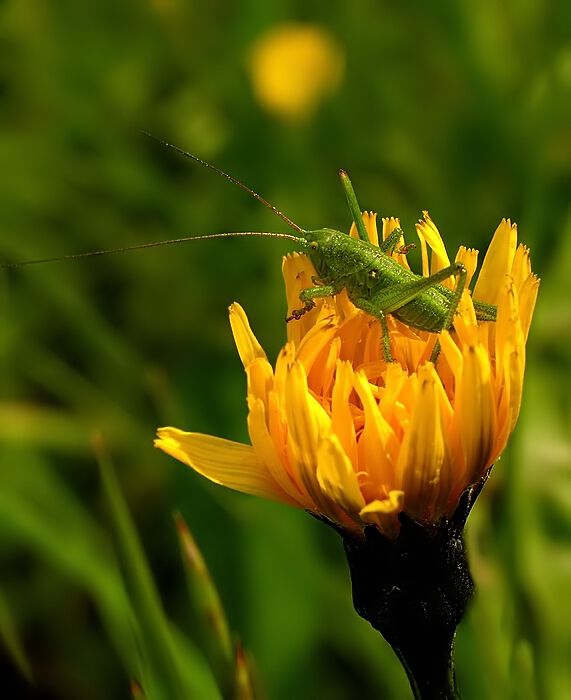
xmin=156 ymin=212 xmax=539 ymax=537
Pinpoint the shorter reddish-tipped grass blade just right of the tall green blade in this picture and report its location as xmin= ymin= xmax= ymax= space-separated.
xmin=174 ymin=513 xmax=234 ymax=692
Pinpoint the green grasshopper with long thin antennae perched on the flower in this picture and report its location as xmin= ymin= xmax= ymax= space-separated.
xmin=1 ymin=138 xmax=497 ymax=362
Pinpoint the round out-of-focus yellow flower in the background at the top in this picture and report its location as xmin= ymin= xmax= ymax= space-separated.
xmin=249 ymin=23 xmax=343 ymax=119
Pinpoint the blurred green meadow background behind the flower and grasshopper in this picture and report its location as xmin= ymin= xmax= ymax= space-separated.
xmin=0 ymin=0 xmax=571 ymax=700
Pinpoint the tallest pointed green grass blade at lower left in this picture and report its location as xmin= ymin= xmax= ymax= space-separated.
xmin=94 ymin=440 xmax=220 ymax=700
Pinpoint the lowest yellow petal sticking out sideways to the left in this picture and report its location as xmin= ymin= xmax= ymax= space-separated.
xmin=155 ymin=428 xmax=291 ymax=504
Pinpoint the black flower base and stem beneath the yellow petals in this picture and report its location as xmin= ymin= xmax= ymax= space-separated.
xmin=318 ymin=479 xmax=485 ymax=700
